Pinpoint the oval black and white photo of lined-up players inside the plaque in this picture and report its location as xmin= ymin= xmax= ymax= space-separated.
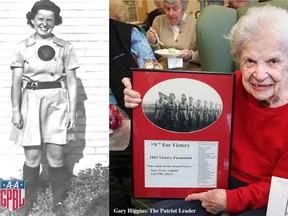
xmin=142 ymin=78 xmax=223 ymax=133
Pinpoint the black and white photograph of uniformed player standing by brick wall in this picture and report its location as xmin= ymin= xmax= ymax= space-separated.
xmin=0 ymin=0 xmax=109 ymax=216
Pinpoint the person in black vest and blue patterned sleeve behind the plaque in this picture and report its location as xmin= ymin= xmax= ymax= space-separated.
xmin=109 ymin=0 xmax=162 ymax=117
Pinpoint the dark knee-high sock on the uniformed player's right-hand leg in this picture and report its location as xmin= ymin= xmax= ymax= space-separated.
xmin=49 ymin=166 xmax=68 ymax=203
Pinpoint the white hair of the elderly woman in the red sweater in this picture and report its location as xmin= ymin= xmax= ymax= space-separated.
xmin=226 ymin=5 xmax=288 ymax=61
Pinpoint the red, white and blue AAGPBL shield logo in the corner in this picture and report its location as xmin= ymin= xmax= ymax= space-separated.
xmin=0 ymin=180 xmax=25 ymax=212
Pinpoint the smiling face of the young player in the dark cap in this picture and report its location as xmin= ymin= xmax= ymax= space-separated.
xmin=32 ymin=10 xmax=55 ymax=39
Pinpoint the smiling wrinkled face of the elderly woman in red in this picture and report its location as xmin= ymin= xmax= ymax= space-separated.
xmin=240 ymin=36 xmax=288 ymax=107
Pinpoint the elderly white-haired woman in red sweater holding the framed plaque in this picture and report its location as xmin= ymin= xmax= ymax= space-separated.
xmin=123 ymin=5 xmax=288 ymax=216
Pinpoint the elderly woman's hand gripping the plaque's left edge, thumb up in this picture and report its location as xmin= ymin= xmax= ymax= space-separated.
xmin=122 ymin=77 xmax=142 ymax=108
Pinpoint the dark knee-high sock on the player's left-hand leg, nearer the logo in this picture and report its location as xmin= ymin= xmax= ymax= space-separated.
xmin=23 ymin=163 xmax=40 ymax=204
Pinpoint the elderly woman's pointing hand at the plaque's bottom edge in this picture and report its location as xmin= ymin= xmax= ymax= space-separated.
xmin=185 ymin=189 xmax=227 ymax=214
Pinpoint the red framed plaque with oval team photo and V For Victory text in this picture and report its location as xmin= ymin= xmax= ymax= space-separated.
xmin=132 ymin=69 xmax=234 ymax=198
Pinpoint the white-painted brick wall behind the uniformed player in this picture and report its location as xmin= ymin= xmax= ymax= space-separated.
xmin=0 ymin=0 xmax=109 ymax=179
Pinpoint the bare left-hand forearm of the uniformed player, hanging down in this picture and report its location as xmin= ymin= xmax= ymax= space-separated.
xmin=11 ymin=67 xmax=23 ymax=129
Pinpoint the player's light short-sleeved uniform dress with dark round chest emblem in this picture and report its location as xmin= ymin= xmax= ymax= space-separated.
xmin=11 ymin=34 xmax=79 ymax=146
